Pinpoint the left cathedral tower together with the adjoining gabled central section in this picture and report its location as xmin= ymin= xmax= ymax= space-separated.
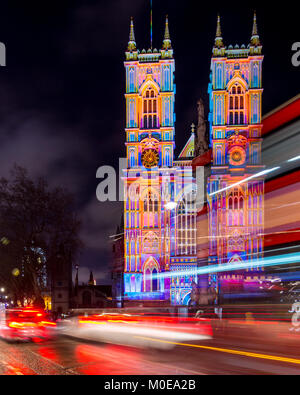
xmin=124 ymin=19 xmax=197 ymax=304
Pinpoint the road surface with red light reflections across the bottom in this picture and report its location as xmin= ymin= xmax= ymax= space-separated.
xmin=0 ymin=325 xmax=300 ymax=375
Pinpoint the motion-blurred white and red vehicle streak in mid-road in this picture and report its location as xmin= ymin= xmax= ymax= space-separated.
xmin=60 ymin=312 xmax=212 ymax=348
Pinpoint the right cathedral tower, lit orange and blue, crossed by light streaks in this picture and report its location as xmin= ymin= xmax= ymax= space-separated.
xmin=207 ymin=14 xmax=264 ymax=292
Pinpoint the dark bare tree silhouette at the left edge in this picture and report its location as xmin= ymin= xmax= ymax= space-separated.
xmin=0 ymin=166 xmax=82 ymax=305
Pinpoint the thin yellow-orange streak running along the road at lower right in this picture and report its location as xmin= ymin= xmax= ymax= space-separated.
xmin=135 ymin=336 xmax=300 ymax=365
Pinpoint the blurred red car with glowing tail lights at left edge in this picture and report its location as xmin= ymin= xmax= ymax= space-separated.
xmin=0 ymin=307 xmax=56 ymax=341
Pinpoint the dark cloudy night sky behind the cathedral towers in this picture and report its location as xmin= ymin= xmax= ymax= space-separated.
xmin=0 ymin=0 xmax=300 ymax=283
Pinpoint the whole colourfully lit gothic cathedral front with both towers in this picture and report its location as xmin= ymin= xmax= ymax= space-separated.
xmin=123 ymin=14 xmax=264 ymax=305
